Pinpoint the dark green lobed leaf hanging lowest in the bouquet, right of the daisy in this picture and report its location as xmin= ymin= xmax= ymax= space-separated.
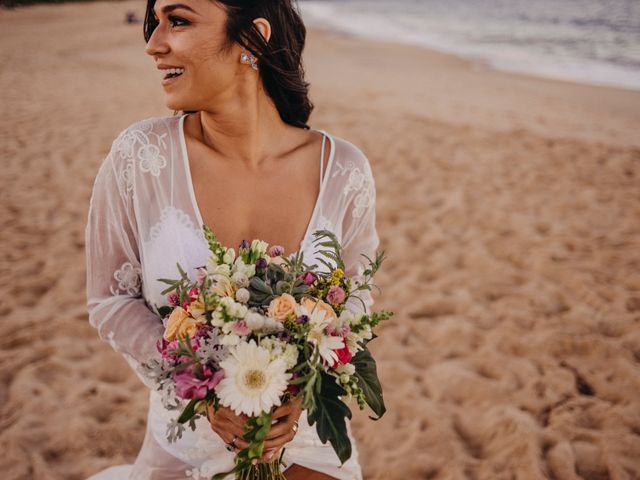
xmin=308 ymin=372 xmax=351 ymax=463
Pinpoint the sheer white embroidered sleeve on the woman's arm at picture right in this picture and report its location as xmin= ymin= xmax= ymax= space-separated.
xmin=342 ymin=150 xmax=380 ymax=312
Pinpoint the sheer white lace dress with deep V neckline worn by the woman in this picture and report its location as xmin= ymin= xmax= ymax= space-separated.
xmin=86 ymin=115 xmax=379 ymax=480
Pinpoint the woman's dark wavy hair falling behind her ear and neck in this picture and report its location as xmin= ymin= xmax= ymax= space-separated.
xmin=144 ymin=0 xmax=313 ymax=129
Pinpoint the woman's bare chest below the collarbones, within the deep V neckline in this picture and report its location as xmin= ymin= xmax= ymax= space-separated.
xmin=185 ymin=147 xmax=320 ymax=252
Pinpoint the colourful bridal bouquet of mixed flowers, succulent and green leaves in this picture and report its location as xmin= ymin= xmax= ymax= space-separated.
xmin=142 ymin=226 xmax=393 ymax=480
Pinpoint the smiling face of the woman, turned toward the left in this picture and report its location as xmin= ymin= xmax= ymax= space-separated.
xmin=146 ymin=0 xmax=242 ymax=110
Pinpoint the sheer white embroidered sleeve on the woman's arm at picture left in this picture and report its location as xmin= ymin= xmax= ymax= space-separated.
xmin=85 ymin=140 xmax=163 ymax=388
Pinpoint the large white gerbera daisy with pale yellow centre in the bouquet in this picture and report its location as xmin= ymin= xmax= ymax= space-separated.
xmin=216 ymin=340 xmax=291 ymax=416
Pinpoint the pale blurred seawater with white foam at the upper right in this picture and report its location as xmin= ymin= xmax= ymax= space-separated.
xmin=298 ymin=0 xmax=640 ymax=90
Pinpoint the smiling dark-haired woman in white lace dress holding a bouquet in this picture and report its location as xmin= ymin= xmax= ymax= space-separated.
xmin=86 ymin=0 xmax=379 ymax=480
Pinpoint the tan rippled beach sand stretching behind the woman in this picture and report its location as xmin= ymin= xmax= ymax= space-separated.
xmin=0 ymin=1 xmax=640 ymax=480
